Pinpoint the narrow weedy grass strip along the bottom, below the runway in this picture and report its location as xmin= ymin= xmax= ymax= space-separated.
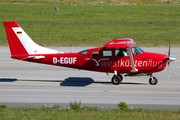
xmin=0 ymin=106 xmax=180 ymax=120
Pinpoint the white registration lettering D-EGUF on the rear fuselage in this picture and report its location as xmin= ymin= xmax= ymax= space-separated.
xmin=53 ymin=57 xmax=77 ymax=64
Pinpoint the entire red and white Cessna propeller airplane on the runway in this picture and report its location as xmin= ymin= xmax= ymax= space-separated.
xmin=4 ymin=21 xmax=176 ymax=85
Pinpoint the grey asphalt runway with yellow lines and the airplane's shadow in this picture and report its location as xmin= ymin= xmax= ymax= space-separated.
xmin=0 ymin=47 xmax=180 ymax=110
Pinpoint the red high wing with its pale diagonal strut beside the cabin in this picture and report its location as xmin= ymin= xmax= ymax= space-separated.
xmin=103 ymin=38 xmax=138 ymax=74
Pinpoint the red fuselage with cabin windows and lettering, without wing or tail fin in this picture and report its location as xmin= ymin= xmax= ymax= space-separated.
xmin=20 ymin=46 xmax=167 ymax=74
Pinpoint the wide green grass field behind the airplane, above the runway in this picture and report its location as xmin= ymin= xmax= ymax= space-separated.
xmin=0 ymin=0 xmax=180 ymax=47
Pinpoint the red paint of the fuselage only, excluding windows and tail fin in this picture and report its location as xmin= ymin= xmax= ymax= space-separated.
xmin=22 ymin=47 xmax=167 ymax=73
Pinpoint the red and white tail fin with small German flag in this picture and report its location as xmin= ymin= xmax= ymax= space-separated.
xmin=3 ymin=21 xmax=63 ymax=57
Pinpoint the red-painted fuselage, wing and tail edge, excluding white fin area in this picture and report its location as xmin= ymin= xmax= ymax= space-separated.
xmin=4 ymin=21 xmax=172 ymax=84
